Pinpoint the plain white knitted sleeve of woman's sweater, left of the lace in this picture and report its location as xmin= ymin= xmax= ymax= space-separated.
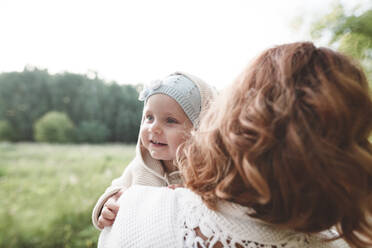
xmin=98 ymin=185 xmax=178 ymax=248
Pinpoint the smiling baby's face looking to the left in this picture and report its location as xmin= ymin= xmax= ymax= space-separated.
xmin=140 ymin=94 xmax=192 ymax=161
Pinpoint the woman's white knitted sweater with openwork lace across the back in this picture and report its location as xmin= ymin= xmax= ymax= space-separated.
xmin=98 ymin=186 xmax=348 ymax=248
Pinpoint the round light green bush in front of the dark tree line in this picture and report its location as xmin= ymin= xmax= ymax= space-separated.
xmin=34 ymin=111 xmax=74 ymax=143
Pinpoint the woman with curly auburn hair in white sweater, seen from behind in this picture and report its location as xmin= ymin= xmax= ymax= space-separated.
xmin=99 ymin=42 xmax=372 ymax=248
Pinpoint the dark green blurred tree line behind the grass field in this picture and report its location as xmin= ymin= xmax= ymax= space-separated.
xmin=0 ymin=67 xmax=142 ymax=143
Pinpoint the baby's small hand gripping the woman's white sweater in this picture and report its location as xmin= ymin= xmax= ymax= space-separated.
xmin=97 ymin=189 xmax=124 ymax=229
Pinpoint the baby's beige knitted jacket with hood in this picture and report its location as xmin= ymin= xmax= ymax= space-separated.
xmin=92 ymin=72 xmax=217 ymax=230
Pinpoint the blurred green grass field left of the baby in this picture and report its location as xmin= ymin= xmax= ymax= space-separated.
xmin=0 ymin=143 xmax=135 ymax=248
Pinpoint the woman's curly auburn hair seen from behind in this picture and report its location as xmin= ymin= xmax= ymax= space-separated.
xmin=178 ymin=42 xmax=372 ymax=247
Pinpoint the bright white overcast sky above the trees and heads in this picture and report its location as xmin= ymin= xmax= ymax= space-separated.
xmin=0 ymin=0 xmax=358 ymax=89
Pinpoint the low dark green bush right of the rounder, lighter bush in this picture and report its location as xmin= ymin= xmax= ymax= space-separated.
xmin=77 ymin=121 xmax=110 ymax=143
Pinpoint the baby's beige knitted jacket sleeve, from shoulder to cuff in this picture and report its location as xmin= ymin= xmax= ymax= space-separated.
xmin=92 ymin=159 xmax=136 ymax=230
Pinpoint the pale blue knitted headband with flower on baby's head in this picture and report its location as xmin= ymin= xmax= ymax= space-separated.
xmin=138 ymin=74 xmax=202 ymax=126
